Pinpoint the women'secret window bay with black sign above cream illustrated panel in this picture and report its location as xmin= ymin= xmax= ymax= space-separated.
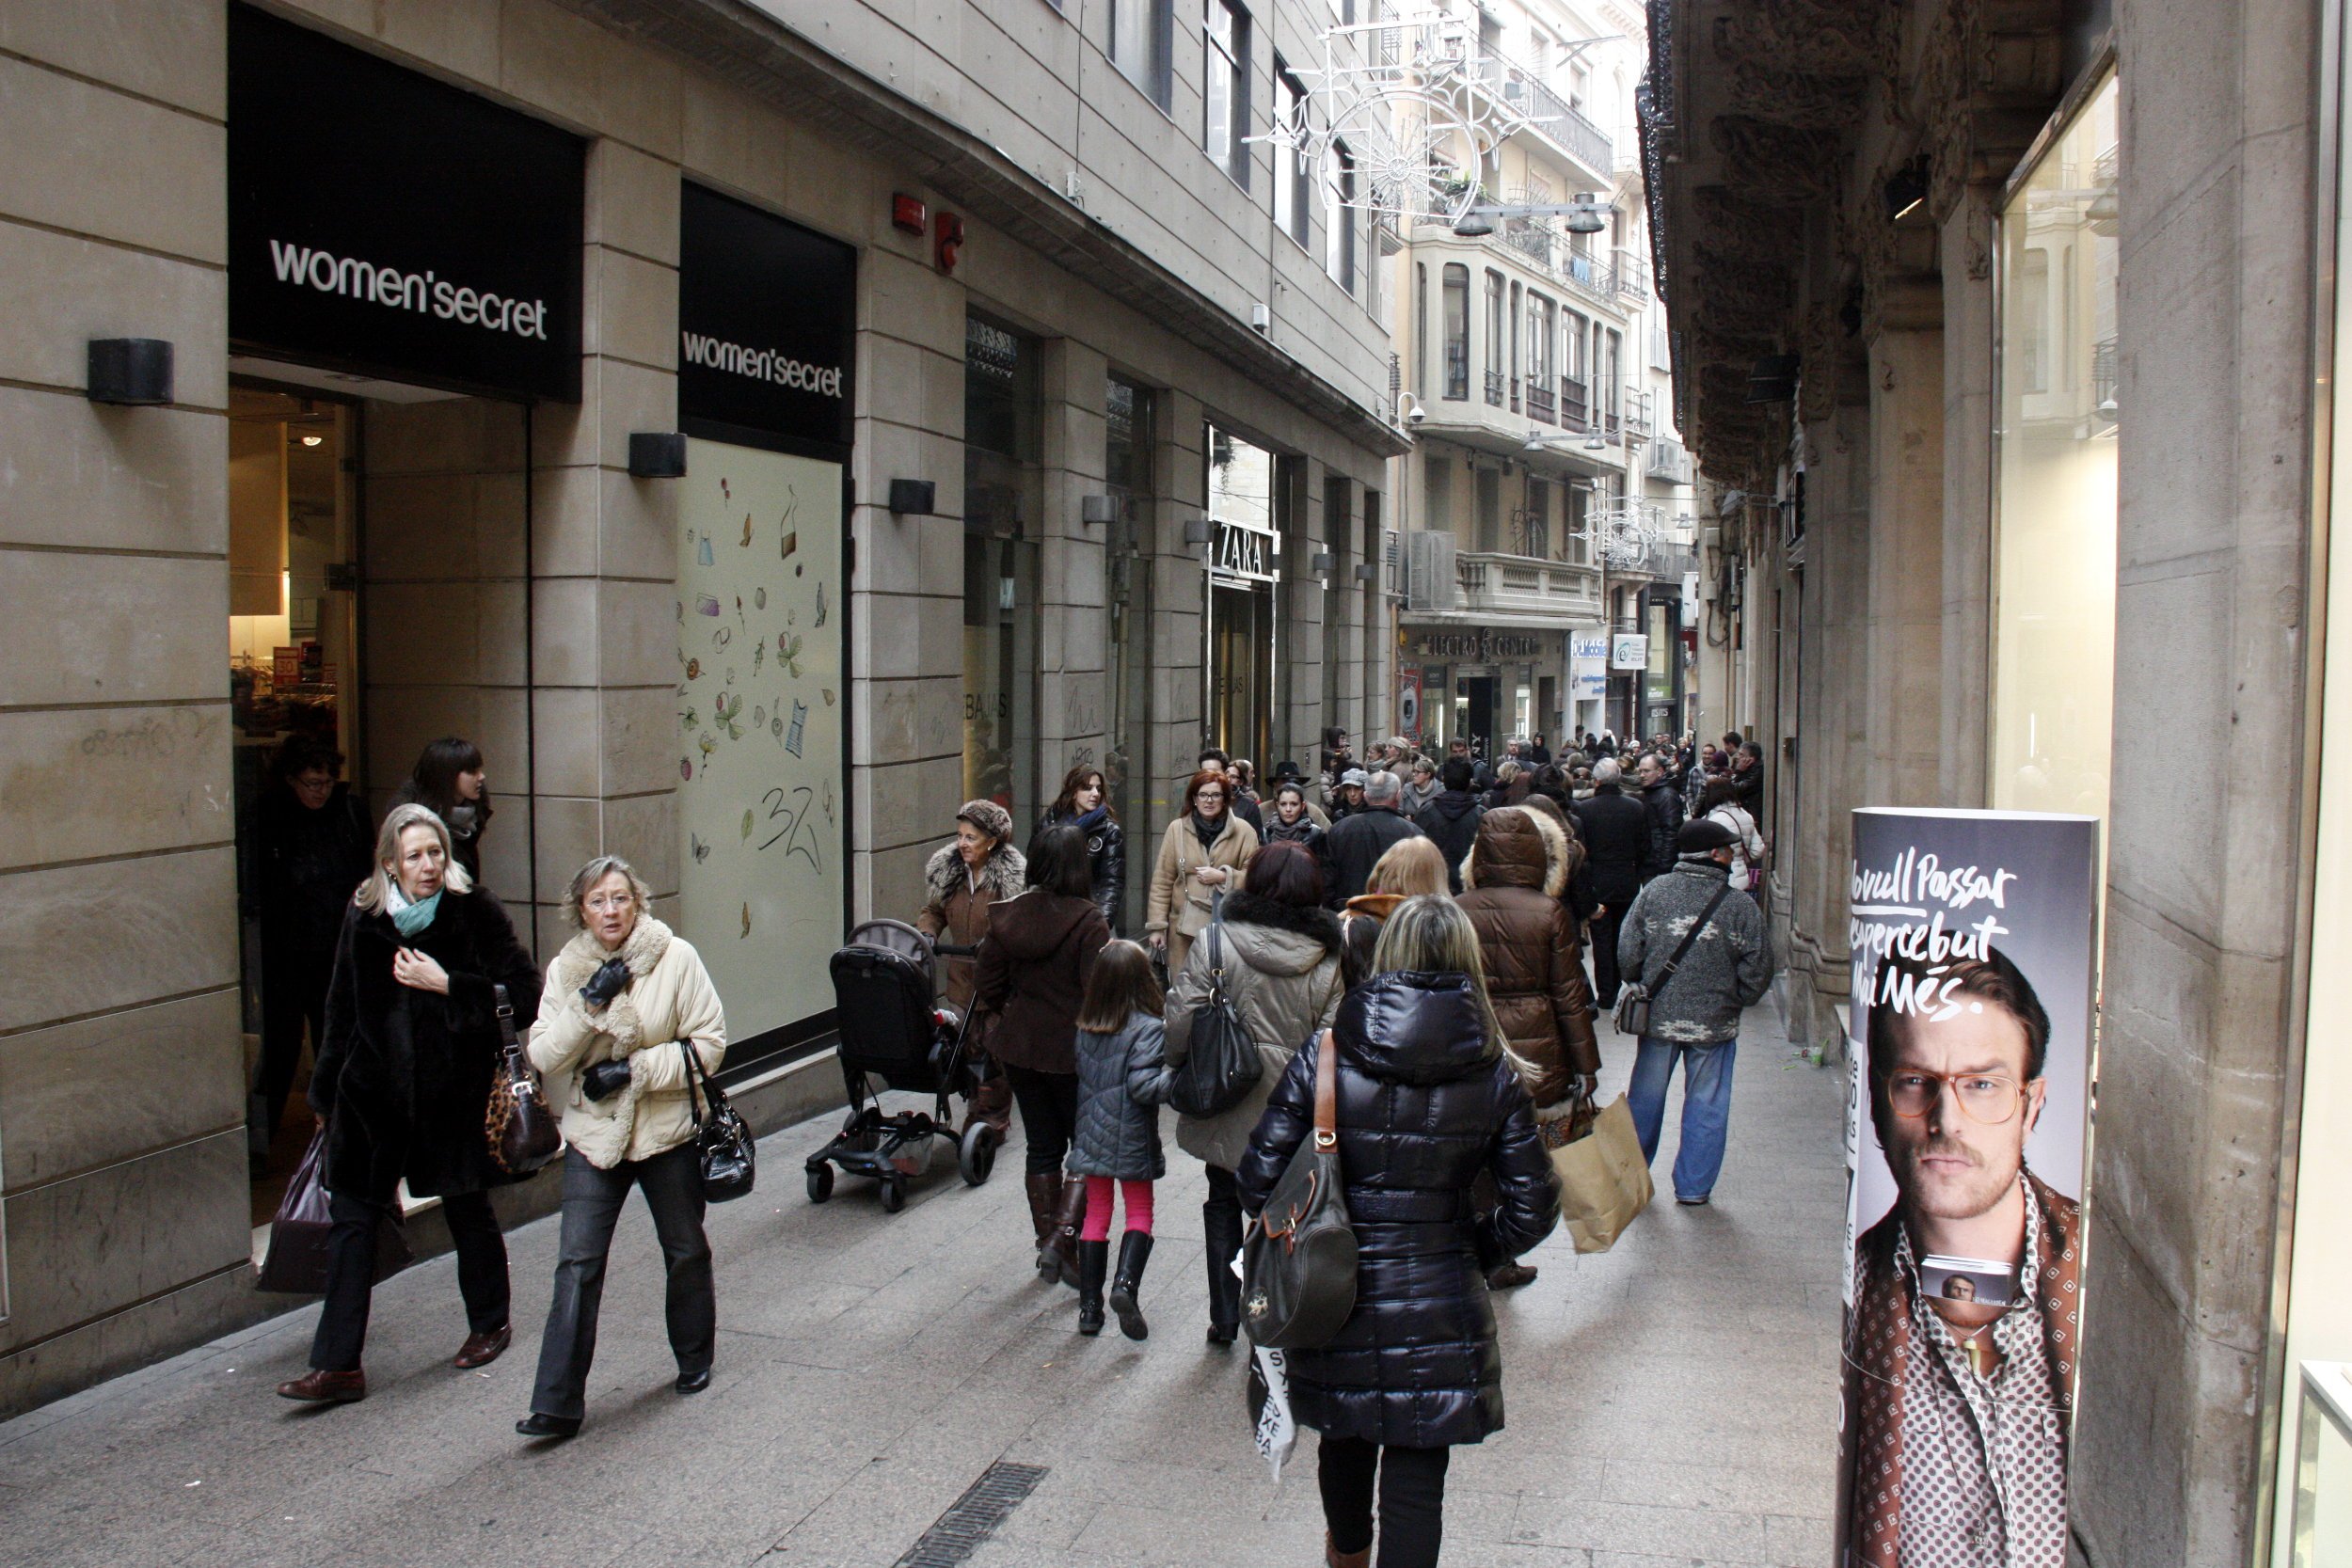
xmin=677 ymin=183 xmax=856 ymax=1063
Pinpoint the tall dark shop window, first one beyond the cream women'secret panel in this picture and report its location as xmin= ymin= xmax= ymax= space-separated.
xmin=964 ymin=315 xmax=1047 ymax=823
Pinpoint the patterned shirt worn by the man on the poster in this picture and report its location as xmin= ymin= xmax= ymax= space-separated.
xmin=1896 ymin=1175 xmax=2065 ymax=1568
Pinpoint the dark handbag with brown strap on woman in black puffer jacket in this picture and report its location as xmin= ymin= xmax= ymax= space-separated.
xmin=1242 ymin=1030 xmax=1355 ymax=1350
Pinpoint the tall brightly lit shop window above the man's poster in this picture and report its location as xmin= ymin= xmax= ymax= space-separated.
xmin=1993 ymin=77 xmax=2122 ymax=818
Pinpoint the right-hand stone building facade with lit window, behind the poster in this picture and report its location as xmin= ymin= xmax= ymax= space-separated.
xmin=1645 ymin=0 xmax=2352 ymax=1568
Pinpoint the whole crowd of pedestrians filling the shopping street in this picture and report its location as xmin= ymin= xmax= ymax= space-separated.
xmin=254 ymin=731 xmax=1772 ymax=1568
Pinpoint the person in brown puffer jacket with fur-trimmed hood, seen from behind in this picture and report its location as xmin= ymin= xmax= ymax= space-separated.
xmin=1461 ymin=806 xmax=1602 ymax=1112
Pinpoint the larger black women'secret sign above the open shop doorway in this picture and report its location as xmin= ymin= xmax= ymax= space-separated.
xmin=229 ymin=5 xmax=586 ymax=402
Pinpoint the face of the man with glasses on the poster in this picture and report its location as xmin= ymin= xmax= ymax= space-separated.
xmin=1872 ymin=997 xmax=2049 ymax=1220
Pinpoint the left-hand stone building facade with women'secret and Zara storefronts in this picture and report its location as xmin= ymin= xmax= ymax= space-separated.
xmin=0 ymin=0 xmax=1405 ymax=1411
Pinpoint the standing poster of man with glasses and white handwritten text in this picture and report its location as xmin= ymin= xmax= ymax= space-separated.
xmin=1837 ymin=809 xmax=2098 ymax=1568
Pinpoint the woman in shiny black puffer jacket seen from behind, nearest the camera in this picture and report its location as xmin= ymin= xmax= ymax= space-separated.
xmin=1235 ymin=895 xmax=1560 ymax=1568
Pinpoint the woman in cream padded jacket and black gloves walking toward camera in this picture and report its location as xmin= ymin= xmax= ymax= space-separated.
xmin=516 ymin=856 xmax=727 ymax=1439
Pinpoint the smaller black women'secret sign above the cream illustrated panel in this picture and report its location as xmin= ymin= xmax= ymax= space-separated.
xmin=677 ymin=183 xmax=859 ymax=458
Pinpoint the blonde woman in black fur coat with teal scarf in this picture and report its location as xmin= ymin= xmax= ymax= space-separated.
xmin=278 ymin=804 xmax=539 ymax=1403
